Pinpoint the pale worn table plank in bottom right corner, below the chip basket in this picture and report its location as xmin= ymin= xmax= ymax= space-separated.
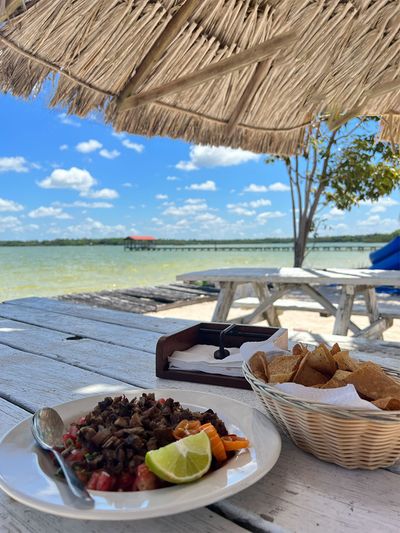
xmin=223 ymin=441 xmax=400 ymax=533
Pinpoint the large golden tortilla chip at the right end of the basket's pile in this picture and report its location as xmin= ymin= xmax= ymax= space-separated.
xmin=345 ymin=362 xmax=400 ymax=400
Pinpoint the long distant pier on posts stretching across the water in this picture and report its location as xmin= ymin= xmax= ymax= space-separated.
xmin=124 ymin=244 xmax=380 ymax=252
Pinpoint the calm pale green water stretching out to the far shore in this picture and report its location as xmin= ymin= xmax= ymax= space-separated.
xmin=0 ymin=243 xmax=376 ymax=301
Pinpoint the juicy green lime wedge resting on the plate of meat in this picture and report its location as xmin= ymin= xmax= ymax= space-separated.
xmin=145 ymin=431 xmax=211 ymax=483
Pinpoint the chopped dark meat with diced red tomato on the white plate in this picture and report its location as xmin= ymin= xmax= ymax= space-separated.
xmin=57 ymin=393 xmax=228 ymax=491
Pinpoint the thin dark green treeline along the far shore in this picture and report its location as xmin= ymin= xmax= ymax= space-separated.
xmin=0 ymin=230 xmax=400 ymax=246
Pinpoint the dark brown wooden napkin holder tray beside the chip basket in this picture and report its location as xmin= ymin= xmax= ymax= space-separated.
xmin=156 ymin=322 xmax=279 ymax=389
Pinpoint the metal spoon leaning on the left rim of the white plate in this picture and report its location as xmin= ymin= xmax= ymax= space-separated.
xmin=32 ymin=407 xmax=94 ymax=507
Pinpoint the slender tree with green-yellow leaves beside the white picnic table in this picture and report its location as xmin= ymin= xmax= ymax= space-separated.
xmin=266 ymin=118 xmax=400 ymax=267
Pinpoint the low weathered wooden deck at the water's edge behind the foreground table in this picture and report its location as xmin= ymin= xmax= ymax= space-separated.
xmin=57 ymin=283 xmax=219 ymax=314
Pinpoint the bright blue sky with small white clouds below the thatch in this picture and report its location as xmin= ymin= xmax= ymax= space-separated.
xmin=0 ymin=95 xmax=400 ymax=240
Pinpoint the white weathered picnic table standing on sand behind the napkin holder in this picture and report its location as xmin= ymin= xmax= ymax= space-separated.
xmin=177 ymin=268 xmax=400 ymax=338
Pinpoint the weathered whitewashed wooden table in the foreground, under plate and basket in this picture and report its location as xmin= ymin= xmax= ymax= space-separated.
xmin=0 ymin=298 xmax=400 ymax=533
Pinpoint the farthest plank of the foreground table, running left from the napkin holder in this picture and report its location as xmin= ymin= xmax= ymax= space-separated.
xmin=6 ymin=298 xmax=194 ymax=333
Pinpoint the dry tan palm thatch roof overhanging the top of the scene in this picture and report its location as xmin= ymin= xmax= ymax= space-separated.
xmin=0 ymin=0 xmax=400 ymax=154
